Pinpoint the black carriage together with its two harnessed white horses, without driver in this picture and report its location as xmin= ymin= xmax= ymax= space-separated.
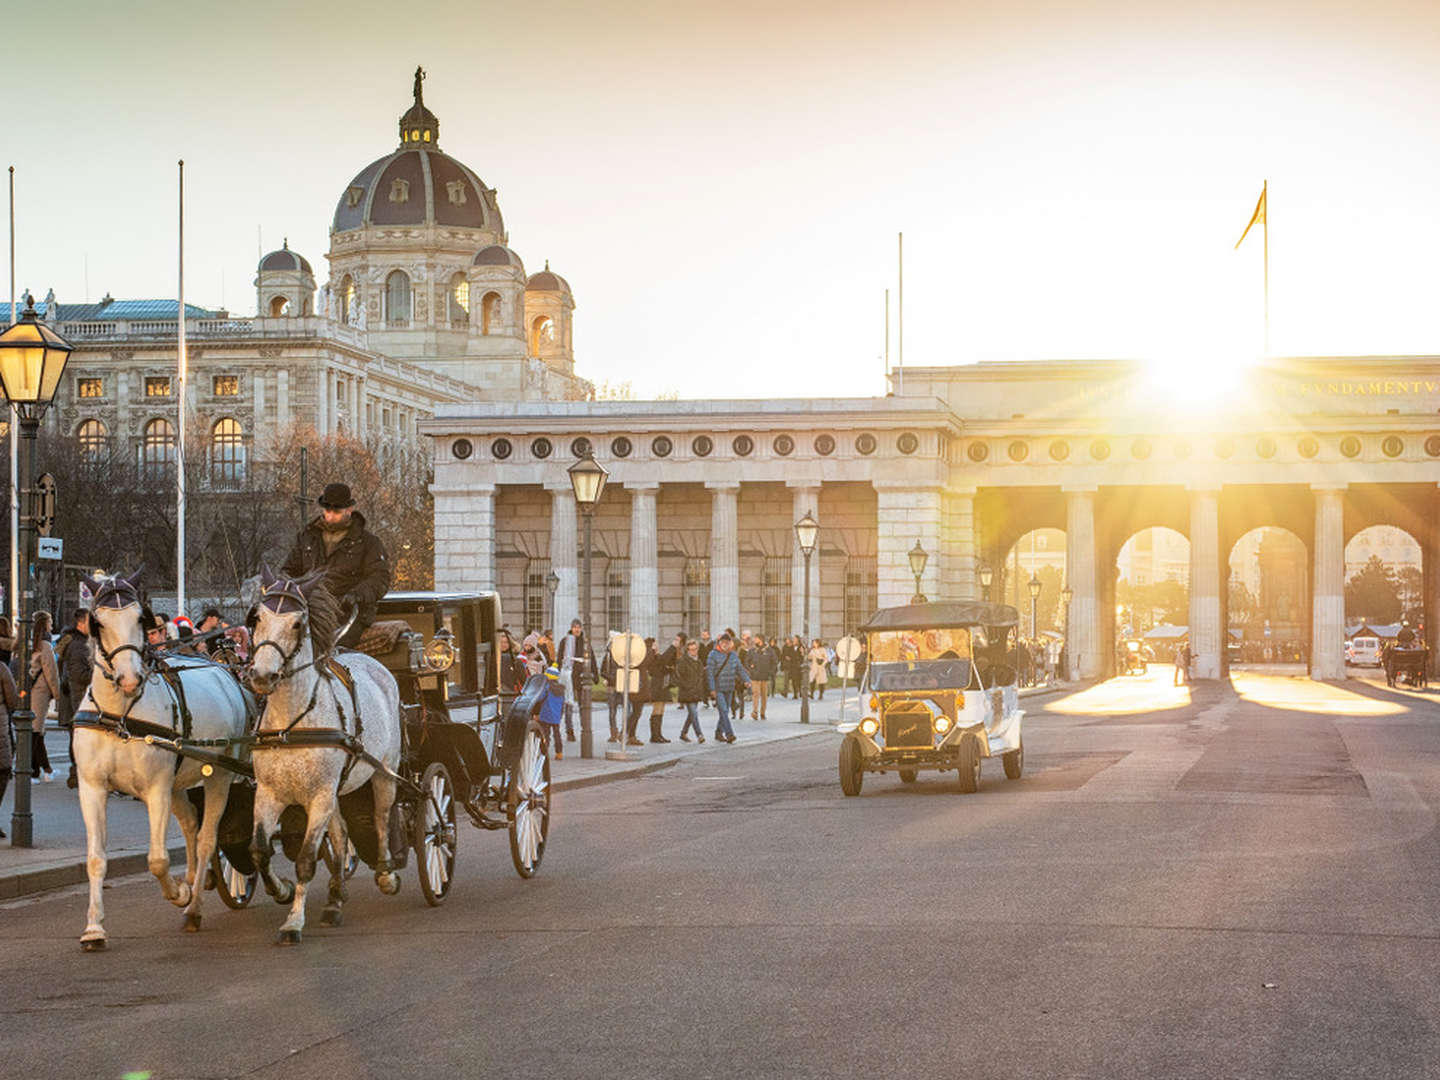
xmin=76 ymin=572 xmax=550 ymax=949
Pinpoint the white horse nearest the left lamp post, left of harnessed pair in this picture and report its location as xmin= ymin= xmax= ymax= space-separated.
xmin=73 ymin=570 xmax=253 ymax=952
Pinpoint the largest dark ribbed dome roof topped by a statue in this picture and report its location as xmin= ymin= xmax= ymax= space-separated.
xmin=331 ymin=69 xmax=505 ymax=236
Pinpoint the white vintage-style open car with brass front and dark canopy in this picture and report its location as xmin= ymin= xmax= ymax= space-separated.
xmin=840 ymin=600 xmax=1025 ymax=795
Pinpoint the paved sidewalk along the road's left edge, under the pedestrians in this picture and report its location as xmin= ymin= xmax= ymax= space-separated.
xmin=0 ymin=687 xmax=1066 ymax=901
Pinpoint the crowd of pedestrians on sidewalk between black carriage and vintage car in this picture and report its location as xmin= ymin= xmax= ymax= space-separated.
xmin=500 ymin=619 xmax=864 ymax=757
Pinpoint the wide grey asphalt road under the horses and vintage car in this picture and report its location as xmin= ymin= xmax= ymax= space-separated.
xmin=0 ymin=667 xmax=1440 ymax=1080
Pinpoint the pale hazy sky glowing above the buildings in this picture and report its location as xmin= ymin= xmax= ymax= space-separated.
xmin=11 ymin=0 xmax=1440 ymax=397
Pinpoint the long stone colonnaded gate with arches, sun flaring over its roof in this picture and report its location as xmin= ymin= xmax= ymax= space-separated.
xmin=422 ymin=356 xmax=1440 ymax=678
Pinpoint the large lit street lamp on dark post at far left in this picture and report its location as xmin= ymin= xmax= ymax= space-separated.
xmin=0 ymin=295 xmax=72 ymax=848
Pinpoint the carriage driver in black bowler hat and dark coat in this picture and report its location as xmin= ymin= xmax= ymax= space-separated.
xmin=281 ymin=484 xmax=390 ymax=648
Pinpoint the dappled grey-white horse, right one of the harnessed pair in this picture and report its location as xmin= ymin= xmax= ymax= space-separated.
xmin=251 ymin=567 xmax=400 ymax=945
